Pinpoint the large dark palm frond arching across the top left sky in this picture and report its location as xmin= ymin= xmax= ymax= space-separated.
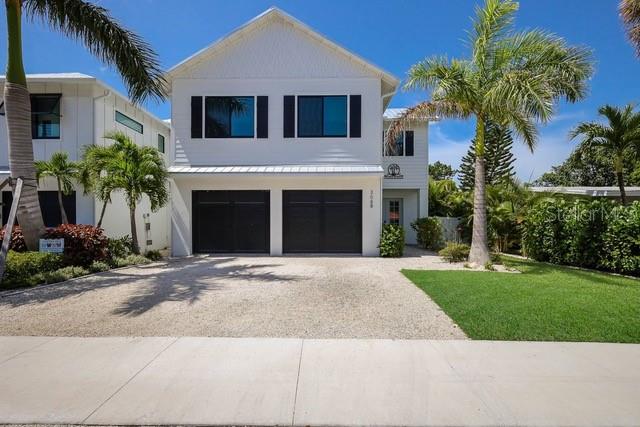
xmin=23 ymin=0 xmax=166 ymax=103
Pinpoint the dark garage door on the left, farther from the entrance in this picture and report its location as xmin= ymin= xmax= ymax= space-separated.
xmin=192 ymin=191 xmax=269 ymax=253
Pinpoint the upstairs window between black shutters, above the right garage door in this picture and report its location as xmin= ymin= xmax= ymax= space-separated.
xmin=298 ymin=95 xmax=347 ymax=138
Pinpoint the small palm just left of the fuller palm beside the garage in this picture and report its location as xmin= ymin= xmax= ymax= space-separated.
xmin=78 ymin=145 xmax=116 ymax=228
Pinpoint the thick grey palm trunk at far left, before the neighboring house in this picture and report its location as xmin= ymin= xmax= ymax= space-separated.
xmin=4 ymin=0 xmax=44 ymax=250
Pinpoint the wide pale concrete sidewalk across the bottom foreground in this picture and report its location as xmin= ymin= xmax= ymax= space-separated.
xmin=0 ymin=337 xmax=640 ymax=426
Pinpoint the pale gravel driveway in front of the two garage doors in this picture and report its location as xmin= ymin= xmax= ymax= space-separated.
xmin=0 ymin=249 xmax=466 ymax=339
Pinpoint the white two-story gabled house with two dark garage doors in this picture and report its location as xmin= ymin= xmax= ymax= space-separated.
xmin=167 ymin=8 xmax=427 ymax=256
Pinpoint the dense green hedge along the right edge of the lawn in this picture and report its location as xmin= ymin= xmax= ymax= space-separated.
xmin=522 ymin=198 xmax=640 ymax=275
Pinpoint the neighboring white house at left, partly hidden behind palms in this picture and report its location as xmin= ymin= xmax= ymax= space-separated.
xmin=0 ymin=73 xmax=170 ymax=250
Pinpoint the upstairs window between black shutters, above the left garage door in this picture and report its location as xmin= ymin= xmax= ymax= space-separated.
xmin=204 ymin=96 xmax=255 ymax=138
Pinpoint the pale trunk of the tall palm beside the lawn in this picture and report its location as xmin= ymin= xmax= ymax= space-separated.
xmin=469 ymin=117 xmax=491 ymax=266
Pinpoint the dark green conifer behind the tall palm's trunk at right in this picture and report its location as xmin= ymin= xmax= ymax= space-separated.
xmin=458 ymin=123 xmax=516 ymax=190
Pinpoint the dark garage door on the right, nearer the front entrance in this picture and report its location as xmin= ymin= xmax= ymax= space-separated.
xmin=283 ymin=190 xmax=362 ymax=253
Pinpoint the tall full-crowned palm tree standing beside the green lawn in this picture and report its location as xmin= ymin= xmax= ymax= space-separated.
xmin=387 ymin=0 xmax=592 ymax=265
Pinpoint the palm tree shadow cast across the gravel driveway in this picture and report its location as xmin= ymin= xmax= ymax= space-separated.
xmin=0 ymin=257 xmax=300 ymax=316
